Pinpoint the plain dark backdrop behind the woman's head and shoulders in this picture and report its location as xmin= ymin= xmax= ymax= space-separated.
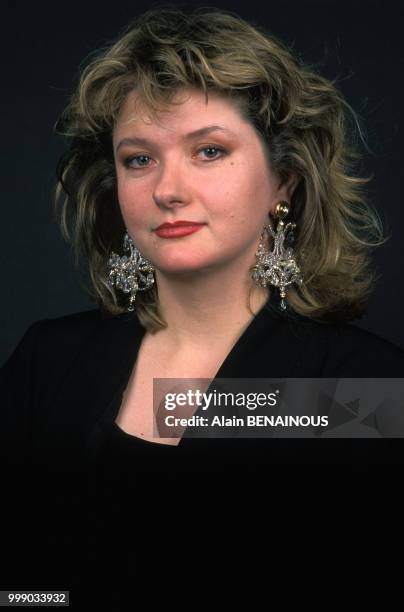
xmin=0 ymin=0 xmax=404 ymax=362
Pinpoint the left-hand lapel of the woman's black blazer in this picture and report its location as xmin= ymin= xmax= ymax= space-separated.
xmin=32 ymin=313 xmax=145 ymax=471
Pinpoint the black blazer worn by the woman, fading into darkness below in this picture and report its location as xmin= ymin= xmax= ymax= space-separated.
xmin=0 ymin=305 xmax=404 ymax=611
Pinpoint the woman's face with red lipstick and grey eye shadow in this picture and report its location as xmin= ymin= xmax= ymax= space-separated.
xmin=113 ymin=90 xmax=291 ymax=274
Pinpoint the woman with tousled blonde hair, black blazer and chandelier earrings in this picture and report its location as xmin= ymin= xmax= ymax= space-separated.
xmin=2 ymin=3 xmax=404 ymax=608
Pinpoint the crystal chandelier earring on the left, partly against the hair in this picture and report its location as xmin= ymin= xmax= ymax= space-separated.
xmin=107 ymin=232 xmax=154 ymax=312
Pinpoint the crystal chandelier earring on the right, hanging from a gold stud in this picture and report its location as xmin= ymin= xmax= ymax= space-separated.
xmin=252 ymin=202 xmax=303 ymax=310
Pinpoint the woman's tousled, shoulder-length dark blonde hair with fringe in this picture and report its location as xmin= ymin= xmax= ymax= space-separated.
xmin=55 ymin=5 xmax=383 ymax=332
